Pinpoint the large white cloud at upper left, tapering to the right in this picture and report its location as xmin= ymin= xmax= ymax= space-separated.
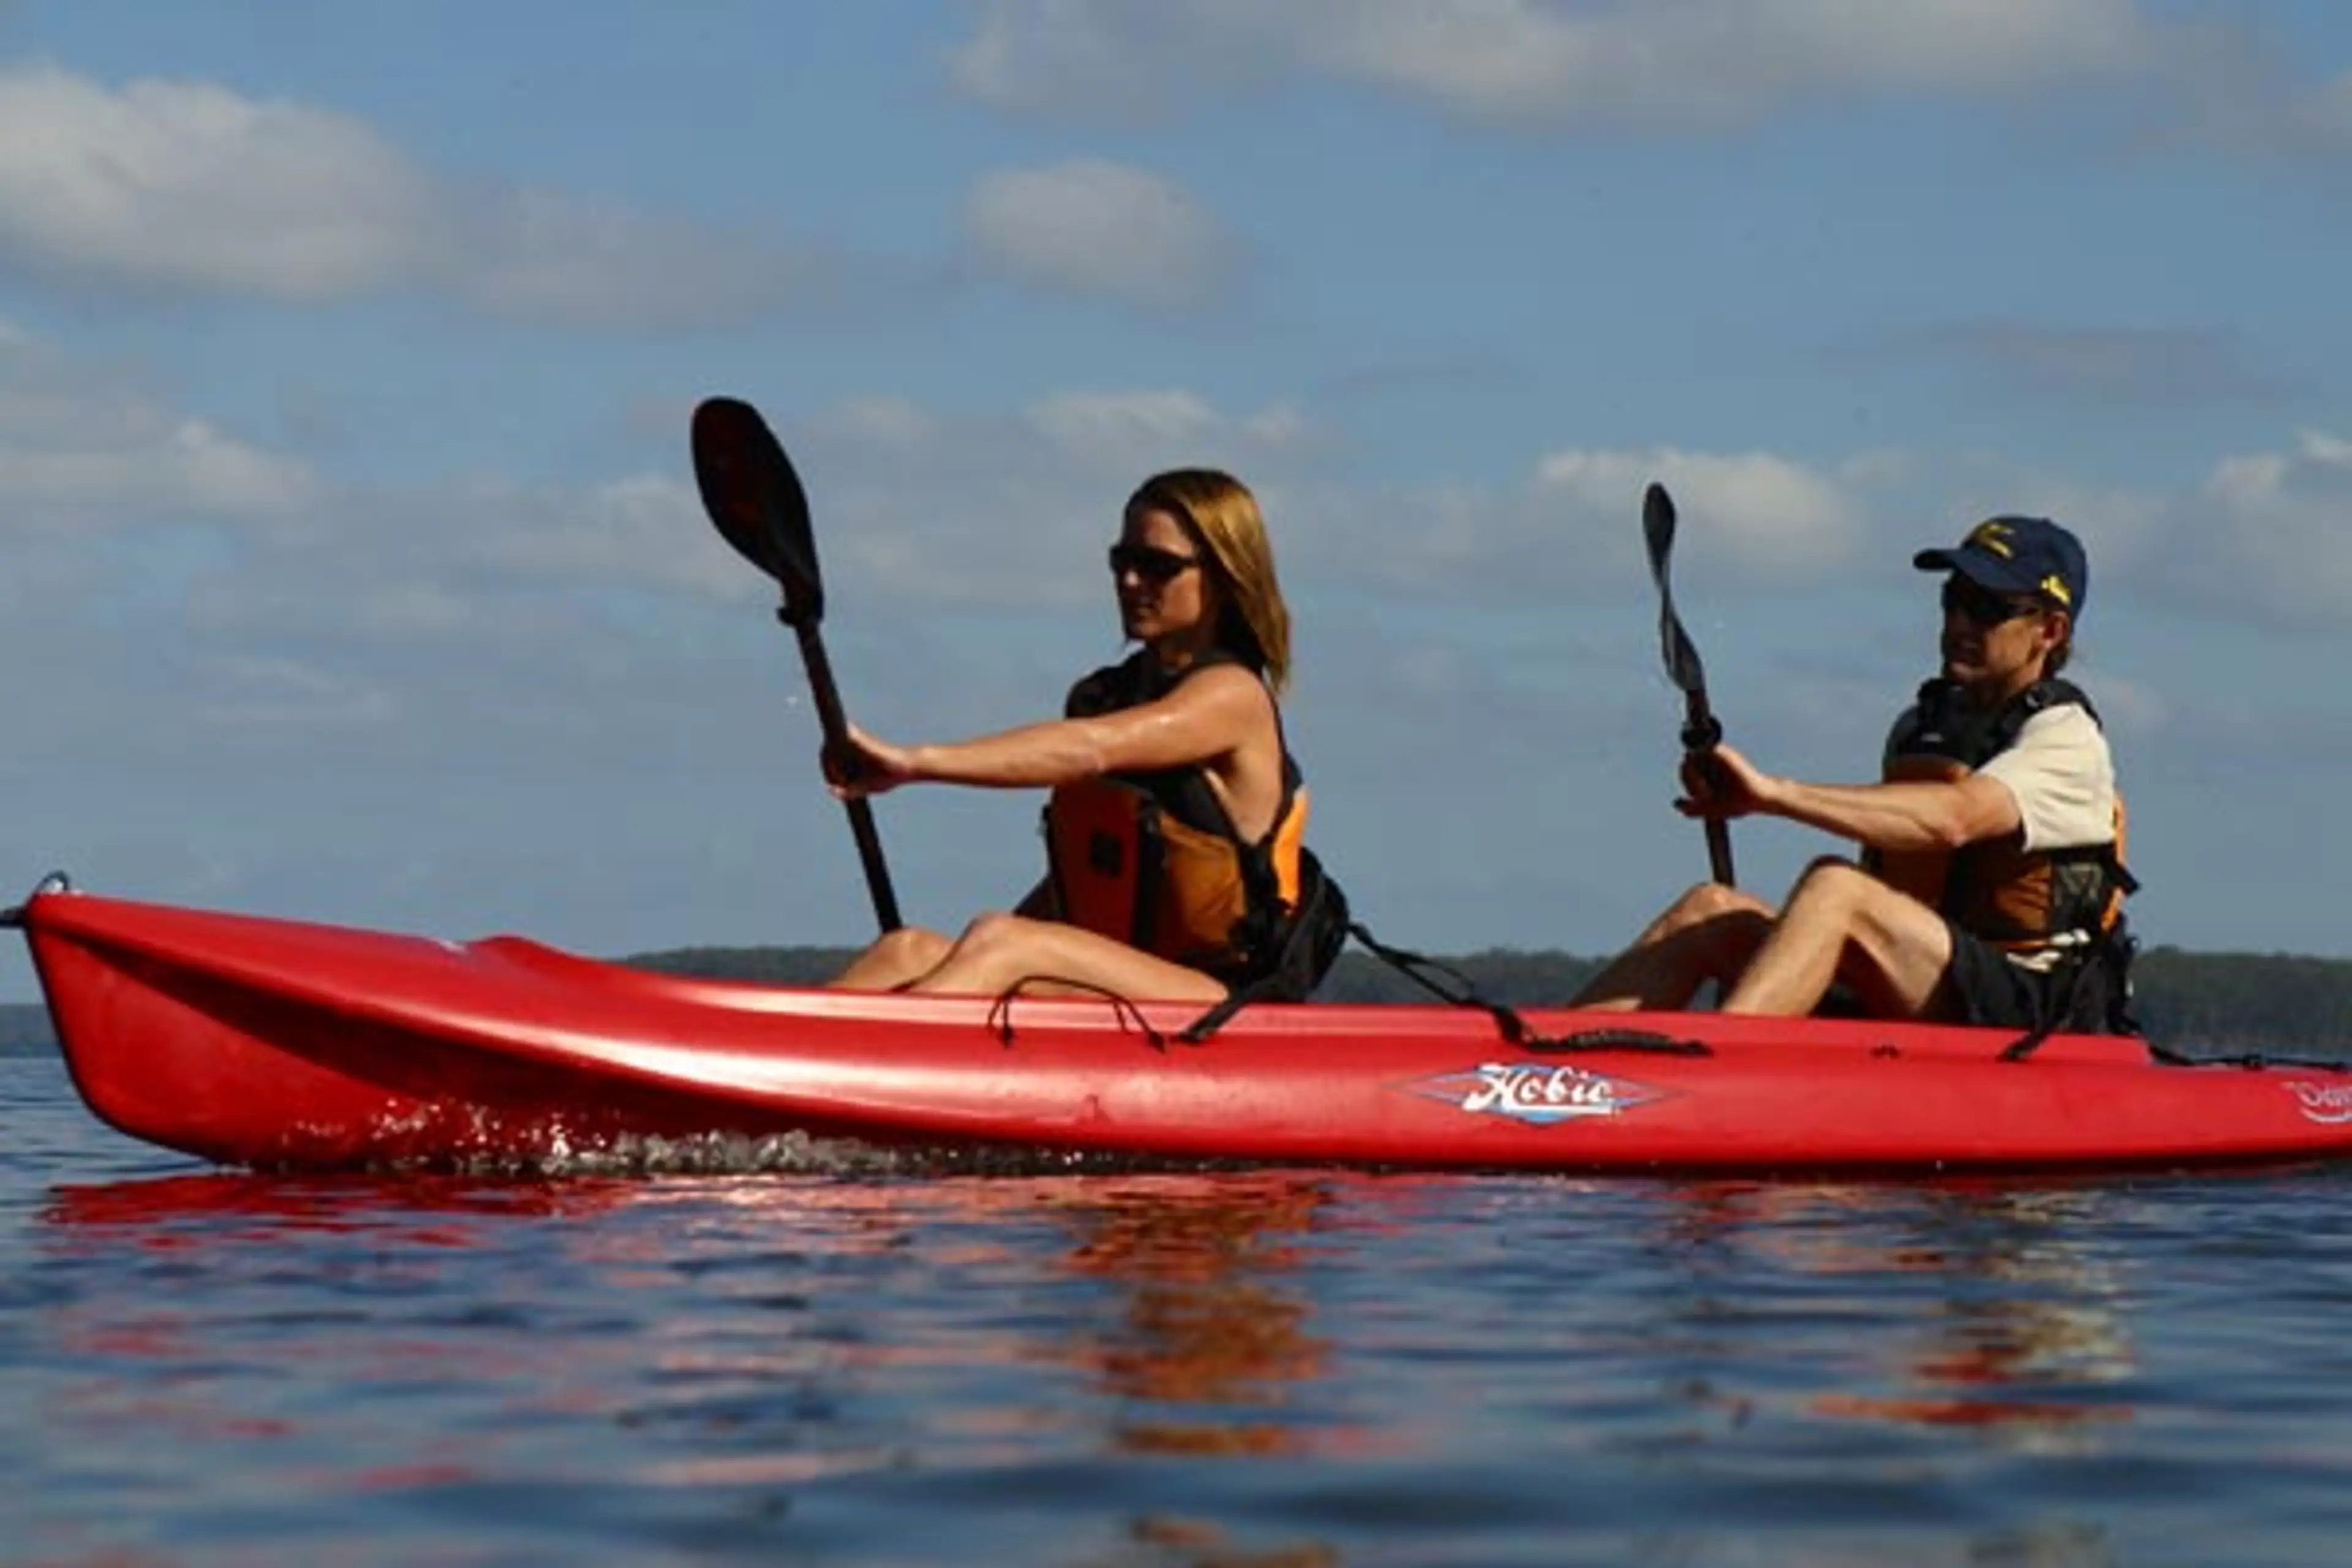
xmin=0 ymin=64 xmax=818 ymax=325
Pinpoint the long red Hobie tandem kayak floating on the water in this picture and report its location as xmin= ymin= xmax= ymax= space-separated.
xmin=21 ymin=884 xmax=2352 ymax=1175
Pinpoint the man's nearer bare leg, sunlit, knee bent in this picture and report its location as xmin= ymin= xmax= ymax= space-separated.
xmin=1724 ymin=861 xmax=1952 ymax=1018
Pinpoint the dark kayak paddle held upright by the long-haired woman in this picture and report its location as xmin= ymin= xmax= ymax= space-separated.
xmin=694 ymin=398 xmax=903 ymax=931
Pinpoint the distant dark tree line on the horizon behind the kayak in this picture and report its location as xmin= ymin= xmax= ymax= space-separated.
xmin=0 ymin=948 xmax=2352 ymax=1055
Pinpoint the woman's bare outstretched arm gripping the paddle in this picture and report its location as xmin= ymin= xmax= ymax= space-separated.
xmin=828 ymin=665 xmax=1270 ymax=794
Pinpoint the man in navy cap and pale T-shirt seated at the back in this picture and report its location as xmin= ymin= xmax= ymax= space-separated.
xmin=1576 ymin=517 xmax=2133 ymax=1032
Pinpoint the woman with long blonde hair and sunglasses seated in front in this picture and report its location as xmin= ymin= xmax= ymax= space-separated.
xmin=826 ymin=468 xmax=1308 ymax=1001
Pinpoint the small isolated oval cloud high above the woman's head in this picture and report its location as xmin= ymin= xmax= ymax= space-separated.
xmin=964 ymin=157 xmax=1232 ymax=306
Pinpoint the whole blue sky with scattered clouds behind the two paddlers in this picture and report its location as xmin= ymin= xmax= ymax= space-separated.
xmin=0 ymin=0 xmax=2352 ymax=995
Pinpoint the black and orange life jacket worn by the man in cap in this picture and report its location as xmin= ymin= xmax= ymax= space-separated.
xmin=1863 ymin=679 xmax=2140 ymax=954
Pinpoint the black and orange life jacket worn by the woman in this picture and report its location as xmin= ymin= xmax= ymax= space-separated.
xmin=1044 ymin=651 xmax=1322 ymax=985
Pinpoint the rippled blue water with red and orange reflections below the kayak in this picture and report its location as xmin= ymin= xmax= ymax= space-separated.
xmin=0 ymin=1058 xmax=2352 ymax=1568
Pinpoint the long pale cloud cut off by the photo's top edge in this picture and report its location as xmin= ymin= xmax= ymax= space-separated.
xmin=950 ymin=0 xmax=2178 ymax=127
